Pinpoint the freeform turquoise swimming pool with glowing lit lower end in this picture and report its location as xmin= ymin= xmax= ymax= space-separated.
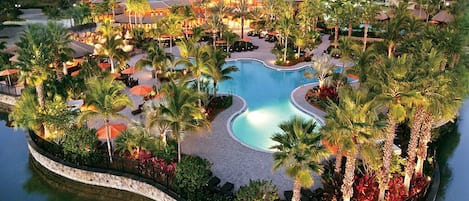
xmin=219 ymin=60 xmax=320 ymax=152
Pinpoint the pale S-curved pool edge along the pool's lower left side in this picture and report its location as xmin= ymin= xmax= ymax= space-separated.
xmin=221 ymin=94 xmax=274 ymax=154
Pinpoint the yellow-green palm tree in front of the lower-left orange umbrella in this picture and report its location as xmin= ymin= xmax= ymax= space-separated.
xmin=77 ymin=76 xmax=132 ymax=163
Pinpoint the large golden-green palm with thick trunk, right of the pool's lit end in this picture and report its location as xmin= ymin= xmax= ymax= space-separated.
xmin=325 ymin=88 xmax=379 ymax=201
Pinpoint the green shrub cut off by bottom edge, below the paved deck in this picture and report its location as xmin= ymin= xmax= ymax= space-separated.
xmin=235 ymin=180 xmax=279 ymax=201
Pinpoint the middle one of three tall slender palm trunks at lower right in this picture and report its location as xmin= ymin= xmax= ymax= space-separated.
xmin=404 ymin=105 xmax=423 ymax=195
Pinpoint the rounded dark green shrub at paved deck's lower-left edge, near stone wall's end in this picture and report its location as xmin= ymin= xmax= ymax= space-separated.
xmin=174 ymin=156 xmax=212 ymax=198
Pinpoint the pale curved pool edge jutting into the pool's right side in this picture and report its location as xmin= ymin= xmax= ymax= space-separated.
xmin=290 ymin=82 xmax=326 ymax=125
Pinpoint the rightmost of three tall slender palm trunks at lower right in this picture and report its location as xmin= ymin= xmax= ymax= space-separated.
xmin=415 ymin=112 xmax=432 ymax=176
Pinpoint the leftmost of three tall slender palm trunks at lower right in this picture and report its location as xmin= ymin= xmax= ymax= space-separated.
xmin=379 ymin=117 xmax=396 ymax=201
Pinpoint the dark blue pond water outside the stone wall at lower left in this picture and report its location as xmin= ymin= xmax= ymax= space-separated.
xmin=0 ymin=112 xmax=148 ymax=201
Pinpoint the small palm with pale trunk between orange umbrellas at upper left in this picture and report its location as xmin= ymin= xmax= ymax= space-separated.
xmin=98 ymin=37 xmax=128 ymax=73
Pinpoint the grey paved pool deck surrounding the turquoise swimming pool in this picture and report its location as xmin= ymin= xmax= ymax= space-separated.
xmin=181 ymin=35 xmax=340 ymax=194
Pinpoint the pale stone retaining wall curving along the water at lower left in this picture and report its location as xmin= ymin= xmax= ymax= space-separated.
xmin=27 ymin=136 xmax=176 ymax=201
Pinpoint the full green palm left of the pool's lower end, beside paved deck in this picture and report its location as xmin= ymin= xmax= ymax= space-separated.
xmin=160 ymin=79 xmax=209 ymax=162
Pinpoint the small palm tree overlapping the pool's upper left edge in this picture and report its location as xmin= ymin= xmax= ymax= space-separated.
xmin=203 ymin=49 xmax=239 ymax=98
